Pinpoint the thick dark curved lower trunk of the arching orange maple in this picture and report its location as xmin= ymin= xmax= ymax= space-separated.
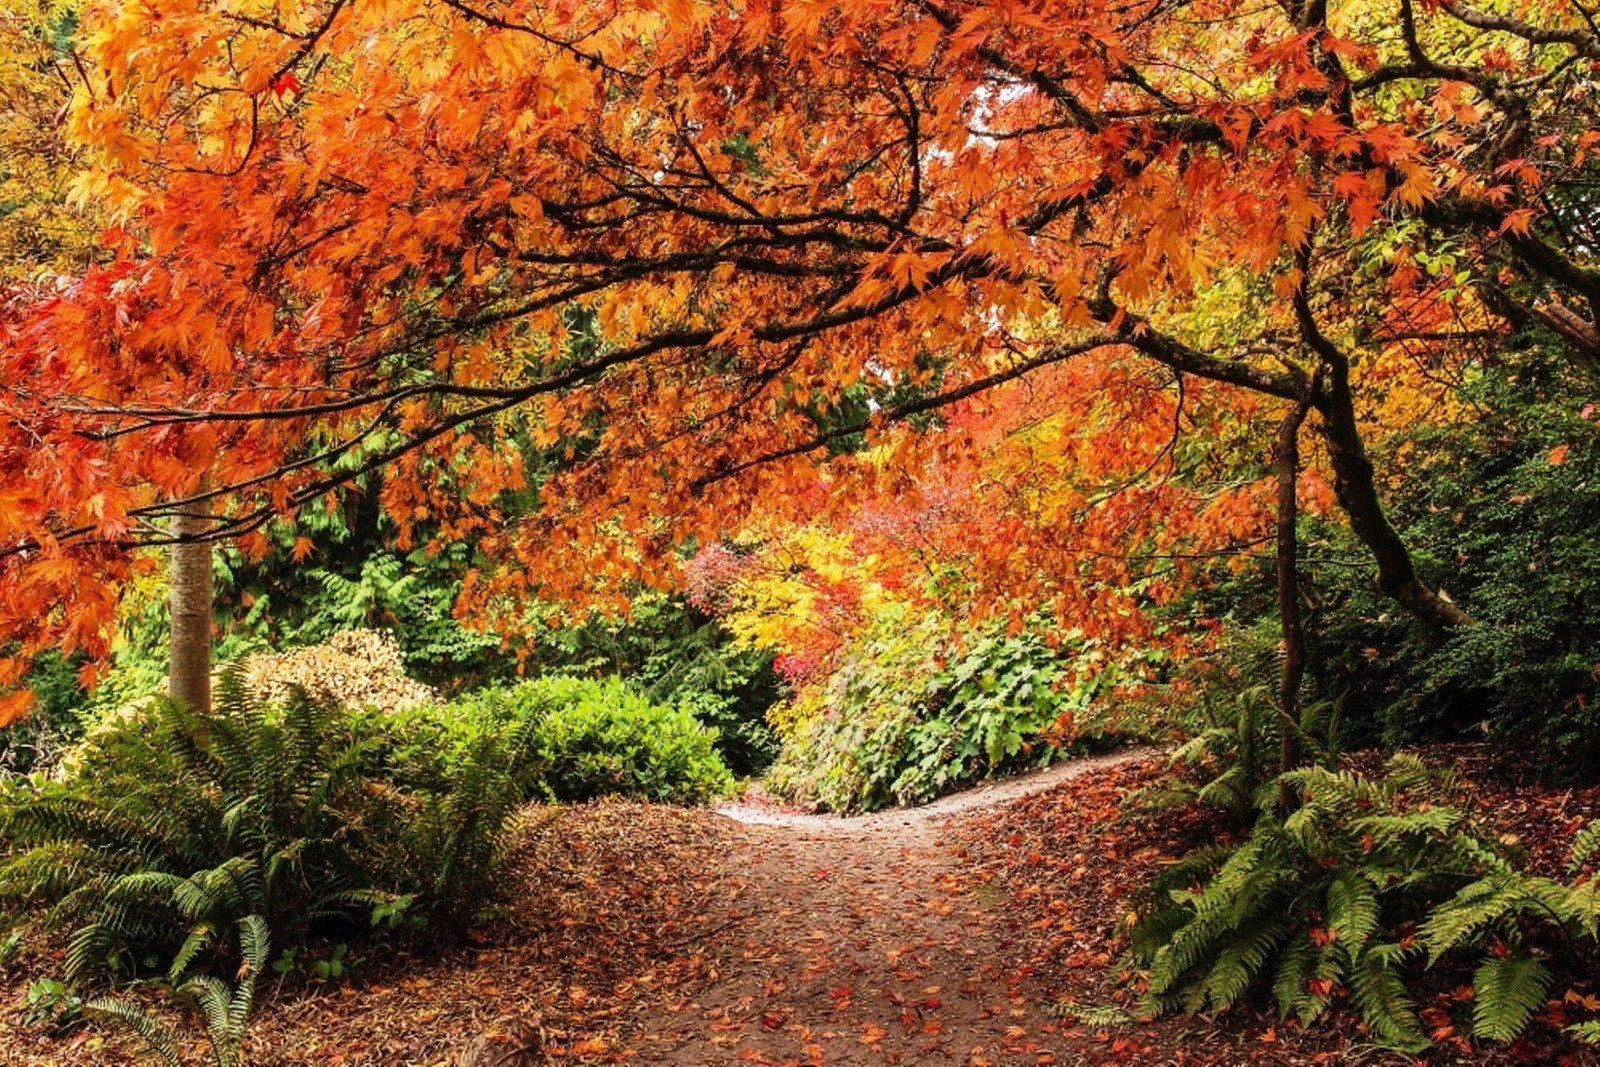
xmin=1315 ymin=360 xmax=1472 ymax=632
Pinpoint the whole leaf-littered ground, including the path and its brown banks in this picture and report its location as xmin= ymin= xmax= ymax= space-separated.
xmin=0 ymin=752 xmax=1600 ymax=1067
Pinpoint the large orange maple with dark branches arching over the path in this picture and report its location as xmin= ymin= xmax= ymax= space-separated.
xmin=0 ymin=0 xmax=1600 ymax=717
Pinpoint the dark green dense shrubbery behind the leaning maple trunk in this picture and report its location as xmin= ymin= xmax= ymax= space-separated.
xmin=1306 ymin=352 xmax=1600 ymax=774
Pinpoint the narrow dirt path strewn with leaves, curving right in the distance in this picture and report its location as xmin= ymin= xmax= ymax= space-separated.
xmin=624 ymin=749 xmax=1152 ymax=1067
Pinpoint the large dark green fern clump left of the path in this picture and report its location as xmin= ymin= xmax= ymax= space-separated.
xmin=0 ymin=677 xmax=533 ymax=984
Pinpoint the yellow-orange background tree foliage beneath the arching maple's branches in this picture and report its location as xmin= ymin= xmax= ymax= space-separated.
xmin=686 ymin=349 xmax=1333 ymax=677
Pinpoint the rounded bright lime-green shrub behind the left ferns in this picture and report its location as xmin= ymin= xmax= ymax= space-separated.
xmin=443 ymin=675 xmax=733 ymax=803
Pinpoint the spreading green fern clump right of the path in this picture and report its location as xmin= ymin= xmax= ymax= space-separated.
xmin=1131 ymin=757 xmax=1600 ymax=1051
